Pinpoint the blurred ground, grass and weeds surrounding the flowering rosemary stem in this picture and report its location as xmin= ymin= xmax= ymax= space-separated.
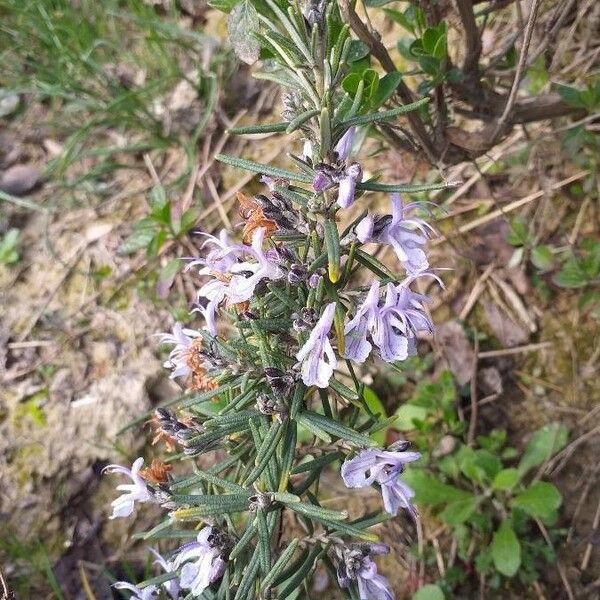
xmin=0 ymin=0 xmax=600 ymax=600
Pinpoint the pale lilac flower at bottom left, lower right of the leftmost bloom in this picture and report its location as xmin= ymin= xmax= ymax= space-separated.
xmin=174 ymin=527 xmax=227 ymax=596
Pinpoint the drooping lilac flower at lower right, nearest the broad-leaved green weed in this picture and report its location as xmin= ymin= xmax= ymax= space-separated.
xmin=342 ymin=444 xmax=421 ymax=515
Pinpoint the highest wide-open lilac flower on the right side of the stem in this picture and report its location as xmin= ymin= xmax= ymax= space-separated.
xmin=375 ymin=194 xmax=433 ymax=275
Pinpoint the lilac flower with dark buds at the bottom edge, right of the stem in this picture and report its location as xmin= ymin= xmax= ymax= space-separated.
xmin=337 ymin=544 xmax=394 ymax=600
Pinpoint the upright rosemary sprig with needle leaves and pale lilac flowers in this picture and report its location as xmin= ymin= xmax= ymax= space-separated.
xmin=107 ymin=0 xmax=450 ymax=600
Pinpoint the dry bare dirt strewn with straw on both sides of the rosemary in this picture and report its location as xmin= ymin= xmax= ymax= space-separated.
xmin=0 ymin=2 xmax=600 ymax=599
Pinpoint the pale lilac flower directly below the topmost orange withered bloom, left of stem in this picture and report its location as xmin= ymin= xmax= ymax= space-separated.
xmin=225 ymin=227 xmax=285 ymax=304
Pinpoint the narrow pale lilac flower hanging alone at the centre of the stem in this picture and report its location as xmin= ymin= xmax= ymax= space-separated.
xmin=296 ymin=302 xmax=337 ymax=388
